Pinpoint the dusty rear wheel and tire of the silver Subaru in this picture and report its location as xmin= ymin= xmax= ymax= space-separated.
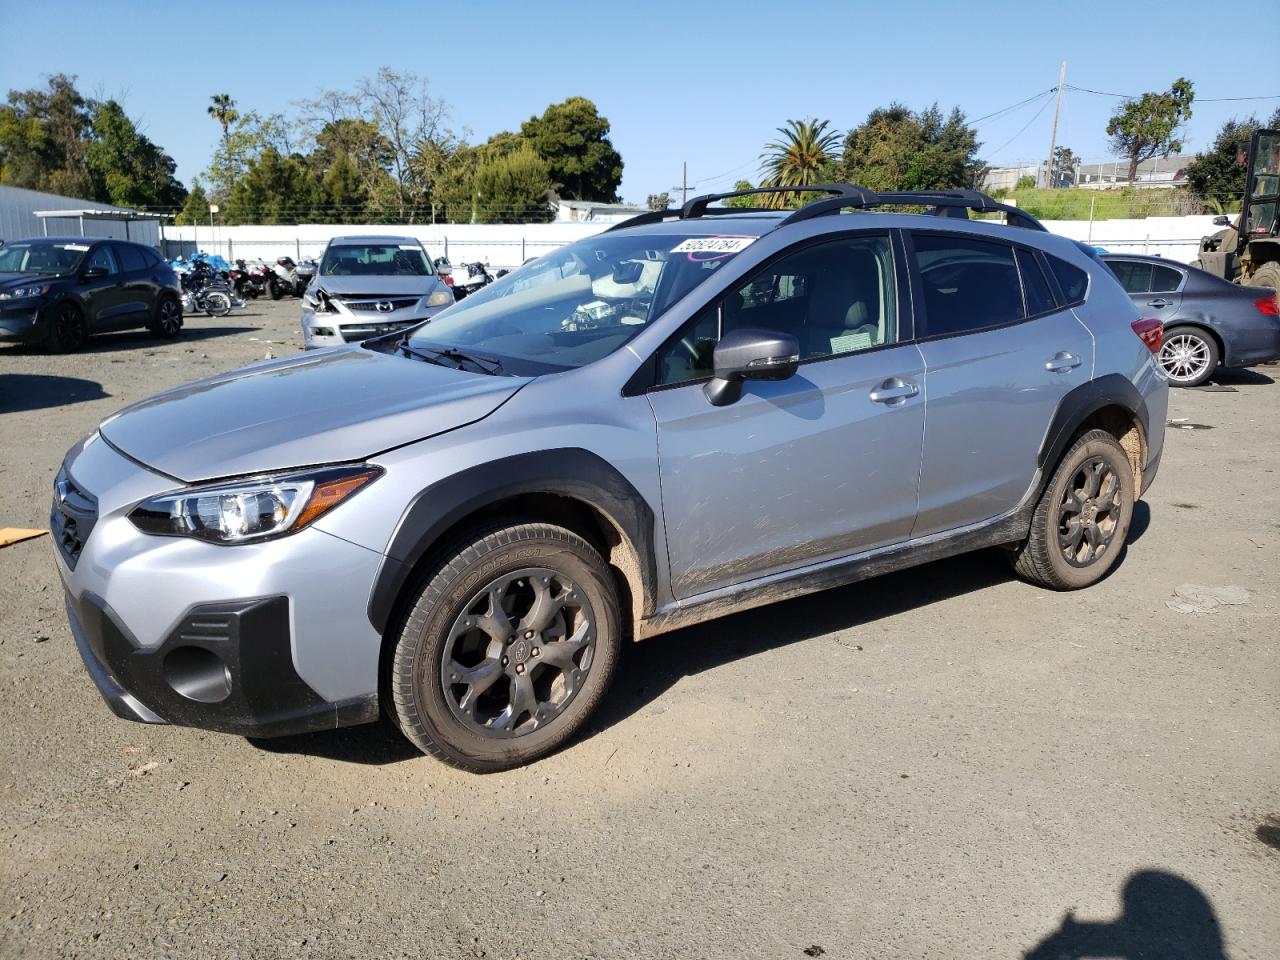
xmin=1011 ymin=430 xmax=1134 ymax=590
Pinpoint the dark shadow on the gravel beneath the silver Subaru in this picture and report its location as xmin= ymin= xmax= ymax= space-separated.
xmin=250 ymin=512 xmax=1151 ymax=765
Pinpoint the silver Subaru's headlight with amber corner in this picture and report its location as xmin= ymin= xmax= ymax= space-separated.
xmin=129 ymin=463 xmax=383 ymax=544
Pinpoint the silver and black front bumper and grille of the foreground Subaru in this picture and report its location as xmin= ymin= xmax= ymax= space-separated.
xmin=51 ymin=435 xmax=381 ymax=736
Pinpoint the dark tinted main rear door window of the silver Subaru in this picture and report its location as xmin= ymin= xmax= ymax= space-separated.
xmin=911 ymin=233 xmax=1025 ymax=337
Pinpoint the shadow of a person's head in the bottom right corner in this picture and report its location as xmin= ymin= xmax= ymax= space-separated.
xmin=1023 ymin=870 xmax=1226 ymax=960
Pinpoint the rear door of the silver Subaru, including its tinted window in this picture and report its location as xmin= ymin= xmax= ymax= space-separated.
xmin=908 ymin=230 xmax=1093 ymax=536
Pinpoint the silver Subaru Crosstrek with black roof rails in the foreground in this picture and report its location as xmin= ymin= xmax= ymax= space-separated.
xmin=52 ymin=184 xmax=1167 ymax=771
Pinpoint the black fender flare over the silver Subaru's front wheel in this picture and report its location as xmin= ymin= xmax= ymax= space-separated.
xmin=369 ymin=447 xmax=657 ymax=634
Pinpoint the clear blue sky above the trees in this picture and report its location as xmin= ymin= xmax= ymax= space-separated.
xmin=0 ymin=0 xmax=1280 ymax=202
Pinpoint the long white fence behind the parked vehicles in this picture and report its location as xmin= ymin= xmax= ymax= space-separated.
xmin=164 ymin=216 xmax=1217 ymax=269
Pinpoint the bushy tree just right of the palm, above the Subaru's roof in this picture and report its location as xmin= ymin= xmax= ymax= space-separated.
xmin=840 ymin=104 xmax=986 ymax=191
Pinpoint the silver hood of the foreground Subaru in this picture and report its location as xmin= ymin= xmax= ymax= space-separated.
xmin=100 ymin=347 xmax=527 ymax=483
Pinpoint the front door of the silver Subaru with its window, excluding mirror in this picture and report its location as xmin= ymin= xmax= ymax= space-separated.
xmin=648 ymin=232 xmax=924 ymax=598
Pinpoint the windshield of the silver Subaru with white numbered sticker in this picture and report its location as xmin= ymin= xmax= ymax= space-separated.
xmin=408 ymin=233 xmax=755 ymax=374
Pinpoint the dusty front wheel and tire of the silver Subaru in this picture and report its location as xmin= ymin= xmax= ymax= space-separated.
xmin=388 ymin=522 xmax=621 ymax=773
